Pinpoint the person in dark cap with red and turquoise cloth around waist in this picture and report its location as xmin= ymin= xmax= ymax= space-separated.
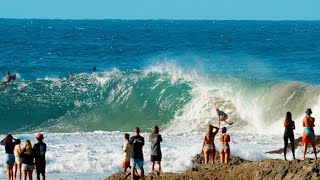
xmin=302 ymin=108 xmax=317 ymax=160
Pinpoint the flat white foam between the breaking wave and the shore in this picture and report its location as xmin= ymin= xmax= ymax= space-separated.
xmin=0 ymin=131 xmax=313 ymax=179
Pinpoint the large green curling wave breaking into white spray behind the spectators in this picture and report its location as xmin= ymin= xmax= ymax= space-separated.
xmin=0 ymin=63 xmax=320 ymax=133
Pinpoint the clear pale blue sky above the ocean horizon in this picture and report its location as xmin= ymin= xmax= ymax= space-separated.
xmin=0 ymin=0 xmax=320 ymax=20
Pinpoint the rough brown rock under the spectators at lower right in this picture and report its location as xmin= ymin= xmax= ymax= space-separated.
xmin=107 ymin=137 xmax=320 ymax=180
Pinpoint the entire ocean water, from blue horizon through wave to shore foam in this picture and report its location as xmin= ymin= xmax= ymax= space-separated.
xmin=0 ymin=19 xmax=320 ymax=179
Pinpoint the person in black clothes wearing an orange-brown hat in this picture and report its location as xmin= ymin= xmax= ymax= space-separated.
xmin=33 ymin=133 xmax=47 ymax=180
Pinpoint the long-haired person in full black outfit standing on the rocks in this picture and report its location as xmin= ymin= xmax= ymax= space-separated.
xmin=283 ymin=111 xmax=296 ymax=160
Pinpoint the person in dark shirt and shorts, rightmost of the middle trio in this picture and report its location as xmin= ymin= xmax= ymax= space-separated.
xmin=149 ymin=126 xmax=162 ymax=172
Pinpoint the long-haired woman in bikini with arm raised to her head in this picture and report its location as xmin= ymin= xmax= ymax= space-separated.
xmin=202 ymin=125 xmax=219 ymax=164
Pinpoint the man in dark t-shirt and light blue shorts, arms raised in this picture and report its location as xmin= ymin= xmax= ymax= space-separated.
xmin=129 ymin=127 xmax=144 ymax=180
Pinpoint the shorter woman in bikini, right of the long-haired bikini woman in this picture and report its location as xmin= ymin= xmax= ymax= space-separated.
xmin=219 ymin=127 xmax=230 ymax=164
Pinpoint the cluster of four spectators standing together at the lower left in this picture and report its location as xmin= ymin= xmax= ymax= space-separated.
xmin=1 ymin=133 xmax=47 ymax=180
